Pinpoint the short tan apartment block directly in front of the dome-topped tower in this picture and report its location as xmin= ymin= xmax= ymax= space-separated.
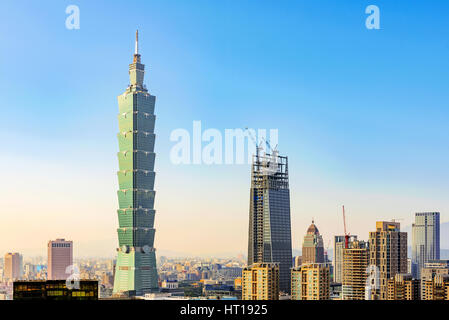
xmin=292 ymin=263 xmax=330 ymax=300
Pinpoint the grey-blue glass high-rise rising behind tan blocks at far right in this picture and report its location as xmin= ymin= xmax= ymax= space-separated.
xmin=412 ymin=212 xmax=440 ymax=279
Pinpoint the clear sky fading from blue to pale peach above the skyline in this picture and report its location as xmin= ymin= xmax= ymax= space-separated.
xmin=0 ymin=0 xmax=449 ymax=255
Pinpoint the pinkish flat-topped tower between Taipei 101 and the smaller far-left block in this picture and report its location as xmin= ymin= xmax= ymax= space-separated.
xmin=47 ymin=239 xmax=73 ymax=280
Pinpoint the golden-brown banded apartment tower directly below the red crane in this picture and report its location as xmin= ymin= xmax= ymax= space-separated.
xmin=342 ymin=240 xmax=369 ymax=300
